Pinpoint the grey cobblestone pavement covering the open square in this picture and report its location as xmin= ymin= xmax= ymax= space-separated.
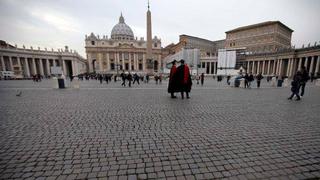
xmin=0 ymin=81 xmax=320 ymax=180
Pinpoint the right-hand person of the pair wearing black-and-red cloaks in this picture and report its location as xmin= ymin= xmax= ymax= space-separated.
xmin=177 ymin=59 xmax=192 ymax=99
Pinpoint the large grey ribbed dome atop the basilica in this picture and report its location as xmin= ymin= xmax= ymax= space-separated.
xmin=111 ymin=14 xmax=134 ymax=40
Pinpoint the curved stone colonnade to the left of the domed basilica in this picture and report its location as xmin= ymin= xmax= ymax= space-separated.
xmin=0 ymin=41 xmax=87 ymax=78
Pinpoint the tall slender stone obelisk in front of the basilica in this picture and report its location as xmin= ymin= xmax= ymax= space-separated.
xmin=146 ymin=0 xmax=153 ymax=74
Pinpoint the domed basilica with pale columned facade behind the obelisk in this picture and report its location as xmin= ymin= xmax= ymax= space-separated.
xmin=85 ymin=14 xmax=163 ymax=74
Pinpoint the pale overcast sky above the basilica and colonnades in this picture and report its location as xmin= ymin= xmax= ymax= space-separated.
xmin=0 ymin=0 xmax=320 ymax=57
